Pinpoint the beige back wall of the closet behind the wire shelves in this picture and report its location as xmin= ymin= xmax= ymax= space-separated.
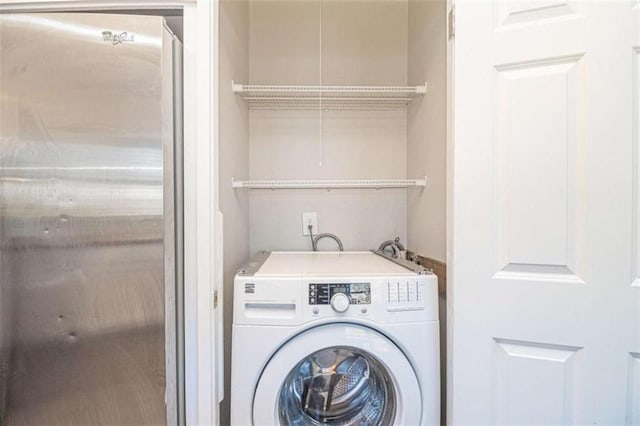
xmin=249 ymin=1 xmax=407 ymax=253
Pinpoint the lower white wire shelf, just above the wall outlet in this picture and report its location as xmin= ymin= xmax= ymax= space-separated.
xmin=231 ymin=176 xmax=427 ymax=189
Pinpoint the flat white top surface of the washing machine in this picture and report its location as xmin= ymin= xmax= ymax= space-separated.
xmin=255 ymin=251 xmax=417 ymax=277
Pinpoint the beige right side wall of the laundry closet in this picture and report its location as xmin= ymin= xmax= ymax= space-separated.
xmin=407 ymin=0 xmax=447 ymax=262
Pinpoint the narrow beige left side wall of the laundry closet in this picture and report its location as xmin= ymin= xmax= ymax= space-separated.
xmin=219 ymin=0 xmax=249 ymax=425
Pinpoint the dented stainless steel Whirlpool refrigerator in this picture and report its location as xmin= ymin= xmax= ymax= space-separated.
xmin=0 ymin=13 xmax=183 ymax=426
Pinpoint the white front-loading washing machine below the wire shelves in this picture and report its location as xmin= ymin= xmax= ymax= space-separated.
xmin=231 ymin=252 xmax=440 ymax=426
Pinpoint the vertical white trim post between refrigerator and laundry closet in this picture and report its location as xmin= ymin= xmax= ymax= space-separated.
xmin=184 ymin=0 xmax=219 ymax=425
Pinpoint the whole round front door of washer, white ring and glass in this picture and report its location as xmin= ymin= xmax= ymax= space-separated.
xmin=253 ymin=323 xmax=422 ymax=426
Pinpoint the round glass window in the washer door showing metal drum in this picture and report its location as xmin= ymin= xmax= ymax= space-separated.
xmin=278 ymin=346 xmax=396 ymax=426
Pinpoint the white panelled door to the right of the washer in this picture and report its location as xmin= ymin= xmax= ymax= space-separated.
xmin=449 ymin=0 xmax=640 ymax=425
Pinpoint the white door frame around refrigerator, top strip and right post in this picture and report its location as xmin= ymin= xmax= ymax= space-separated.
xmin=0 ymin=0 xmax=224 ymax=425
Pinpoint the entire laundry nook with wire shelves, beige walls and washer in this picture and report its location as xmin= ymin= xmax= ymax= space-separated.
xmin=219 ymin=1 xmax=447 ymax=425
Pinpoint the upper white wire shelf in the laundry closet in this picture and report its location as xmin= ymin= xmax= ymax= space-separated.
xmin=231 ymin=81 xmax=427 ymax=110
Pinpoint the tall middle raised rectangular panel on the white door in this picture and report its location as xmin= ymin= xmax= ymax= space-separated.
xmin=494 ymin=53 xmax=585 ymax=283
